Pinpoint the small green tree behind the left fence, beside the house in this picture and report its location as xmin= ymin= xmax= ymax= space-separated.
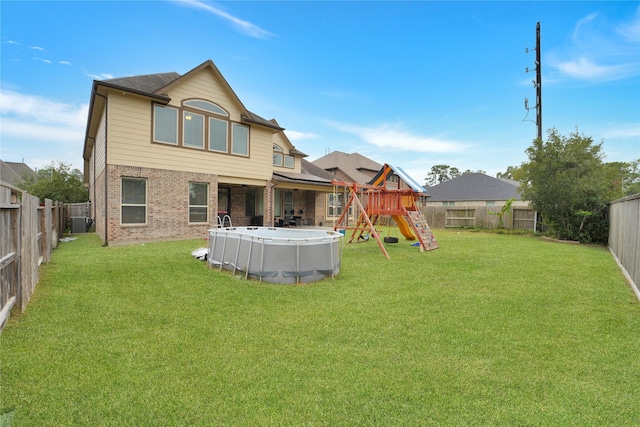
xmin=24 ymin=162 xmax=89 ymax=203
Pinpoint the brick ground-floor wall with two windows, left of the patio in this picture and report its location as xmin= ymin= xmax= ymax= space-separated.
xmin=106 ymin=165 xmax=219 ymax=244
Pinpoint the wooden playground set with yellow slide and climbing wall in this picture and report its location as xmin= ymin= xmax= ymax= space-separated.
xmin=332 ymin=164 xmax=438 ymax=259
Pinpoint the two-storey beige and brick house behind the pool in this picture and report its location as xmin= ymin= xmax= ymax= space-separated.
xmin=83 ymin=60 xmax=332 ymax=244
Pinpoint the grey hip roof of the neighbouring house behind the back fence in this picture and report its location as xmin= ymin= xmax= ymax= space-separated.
xmin=427 ymin=173 xmax=521 ymax=202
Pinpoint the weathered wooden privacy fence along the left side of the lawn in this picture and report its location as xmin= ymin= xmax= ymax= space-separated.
xmin=0 ymin=182 xmax=66 ymax=331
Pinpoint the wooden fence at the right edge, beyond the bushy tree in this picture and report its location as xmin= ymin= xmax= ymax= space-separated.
xmin=609 ymin=194 xmax=640 ymax=299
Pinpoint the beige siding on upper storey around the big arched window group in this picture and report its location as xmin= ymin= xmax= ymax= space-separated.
xmin=107 ymin=92 xmax=273 ymax=183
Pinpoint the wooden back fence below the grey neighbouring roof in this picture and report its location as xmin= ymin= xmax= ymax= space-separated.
xmin=420 ymin=206 xmax=537 ymax=231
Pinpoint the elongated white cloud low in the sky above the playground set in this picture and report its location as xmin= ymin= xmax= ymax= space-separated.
xmin=329 ymin=122 xmax=465 ymax=153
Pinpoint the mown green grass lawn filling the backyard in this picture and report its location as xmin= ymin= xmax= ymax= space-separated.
xmin=0 ymin=230 xmax=640 ymax=426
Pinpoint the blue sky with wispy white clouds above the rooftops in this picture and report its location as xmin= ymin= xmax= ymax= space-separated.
xmin=0 ymin=0 xmax=640 ymax=182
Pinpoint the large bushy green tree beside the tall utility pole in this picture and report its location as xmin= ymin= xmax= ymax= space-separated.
xmin=521 ymin=129 xmax=611 ymax=243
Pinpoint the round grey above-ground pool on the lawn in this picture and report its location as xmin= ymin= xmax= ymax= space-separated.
xmin=207 ymin=227 xmax=342 ymax=283
